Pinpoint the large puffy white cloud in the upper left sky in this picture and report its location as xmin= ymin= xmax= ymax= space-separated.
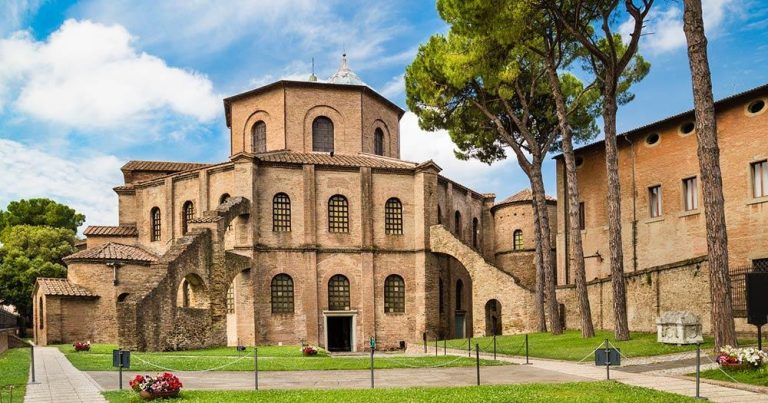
xmin=0 ymin=20 xmax=221 ymax=130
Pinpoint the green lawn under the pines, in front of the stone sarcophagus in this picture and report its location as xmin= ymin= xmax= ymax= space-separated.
xmin=444 ymin=330 xmax=714 ymax=361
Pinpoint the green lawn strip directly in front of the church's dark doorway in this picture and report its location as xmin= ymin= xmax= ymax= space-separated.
xmin=57 ymin=344 xmax=503 ymax=372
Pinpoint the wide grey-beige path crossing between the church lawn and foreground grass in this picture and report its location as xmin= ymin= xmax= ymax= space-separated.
xmin=88 ymin=365 xmax=591 ymax=390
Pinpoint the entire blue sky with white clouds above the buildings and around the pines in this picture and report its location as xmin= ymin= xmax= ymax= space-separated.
xmin=0 ymin=0 xmax=768 ymax=230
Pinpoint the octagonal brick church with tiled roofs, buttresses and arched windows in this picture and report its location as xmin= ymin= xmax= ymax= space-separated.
xmin=33 ymin=59 xmax=544 ymax=351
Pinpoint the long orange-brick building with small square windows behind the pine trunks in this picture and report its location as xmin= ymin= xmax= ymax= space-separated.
xmin=556 ymin=85 xmax=768 ymax=331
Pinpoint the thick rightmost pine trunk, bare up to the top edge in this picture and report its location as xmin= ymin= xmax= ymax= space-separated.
xmin=683 ymin=0 xmax=736 ymax=349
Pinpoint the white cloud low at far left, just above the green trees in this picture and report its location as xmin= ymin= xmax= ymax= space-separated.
xmin=0 ymin=139 xmax=123 ymax=230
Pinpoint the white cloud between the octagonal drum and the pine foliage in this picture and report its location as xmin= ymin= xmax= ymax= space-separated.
xmin=400 ymin=112 xmax=529 ymax=192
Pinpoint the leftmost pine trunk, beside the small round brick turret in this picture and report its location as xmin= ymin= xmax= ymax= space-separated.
xmin=531 ymin=163 xmax=563 ymax=334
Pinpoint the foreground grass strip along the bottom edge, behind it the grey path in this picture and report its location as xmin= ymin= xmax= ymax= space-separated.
xmin=104 ymin=381 xmax=694 ymax=403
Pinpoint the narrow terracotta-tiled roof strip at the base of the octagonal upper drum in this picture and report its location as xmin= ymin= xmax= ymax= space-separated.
xmin=257 ymin=151 xmax=418 ymax=169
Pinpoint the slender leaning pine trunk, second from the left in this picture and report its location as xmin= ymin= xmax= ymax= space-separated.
xmin=547 ymin=61 xmax=595 ymax=337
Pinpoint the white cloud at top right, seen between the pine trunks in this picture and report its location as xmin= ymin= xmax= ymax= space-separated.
xmin=619 ymin=0 xmax=739 ymax=54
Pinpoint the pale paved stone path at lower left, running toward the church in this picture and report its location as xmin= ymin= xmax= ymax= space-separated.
xmin=24 ymin=347 xmax=106 ymax=403
